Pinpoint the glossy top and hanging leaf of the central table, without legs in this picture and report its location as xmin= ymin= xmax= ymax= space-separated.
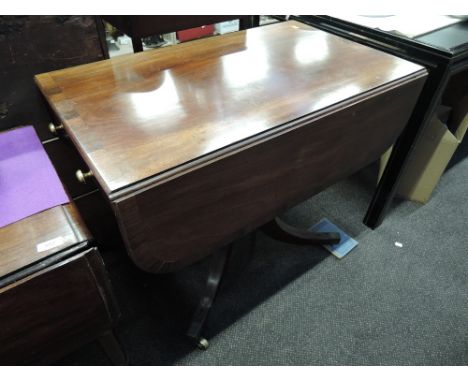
xmin=36 ymin=21 xmax=426 ymax=272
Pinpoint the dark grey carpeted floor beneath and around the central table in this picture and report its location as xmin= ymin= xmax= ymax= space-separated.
xmin=60 ymin=151 xmax=468 ymax=365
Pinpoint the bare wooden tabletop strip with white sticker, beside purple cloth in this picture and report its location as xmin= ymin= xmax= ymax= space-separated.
xmin=0 ymin=203 xmax=90 ymax=278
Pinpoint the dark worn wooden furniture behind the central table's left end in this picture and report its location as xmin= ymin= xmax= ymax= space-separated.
xmin=0 ymin=16 xmax=107 ymax=140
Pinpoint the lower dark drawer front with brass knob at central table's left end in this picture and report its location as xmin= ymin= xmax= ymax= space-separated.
xmin=44 ymin=137 xmax=97 ymax=198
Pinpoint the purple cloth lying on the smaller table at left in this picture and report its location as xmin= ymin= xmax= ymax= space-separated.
xmin=0 ymin=126 xmax=69 ymax=228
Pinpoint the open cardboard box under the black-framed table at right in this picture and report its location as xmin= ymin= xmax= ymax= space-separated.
xmin=379 ymin=100 xmax=468 ymax=203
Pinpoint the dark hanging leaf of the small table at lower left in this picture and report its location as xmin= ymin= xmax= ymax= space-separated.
xmin=0 ymin=248 xmax=117 ymax=365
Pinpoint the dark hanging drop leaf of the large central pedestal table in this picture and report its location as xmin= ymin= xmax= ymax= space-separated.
xmin=115 ymin=78 xmax=425 ymax=272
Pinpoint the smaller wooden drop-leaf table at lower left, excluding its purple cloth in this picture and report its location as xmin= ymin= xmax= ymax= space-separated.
xmin=0 ymin=204 xmax=124 ymax=365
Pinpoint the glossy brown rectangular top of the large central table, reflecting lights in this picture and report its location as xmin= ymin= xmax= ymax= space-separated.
xmin=36 ymin=21 xmax=425 ymax=194
